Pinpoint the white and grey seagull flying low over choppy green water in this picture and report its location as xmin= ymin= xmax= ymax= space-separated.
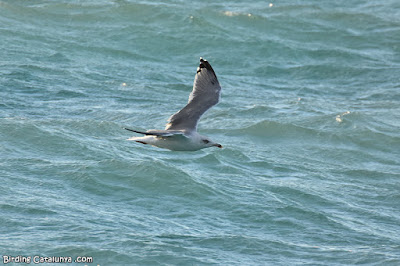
xmin=124 ymin=57 xmax=222 ymax=151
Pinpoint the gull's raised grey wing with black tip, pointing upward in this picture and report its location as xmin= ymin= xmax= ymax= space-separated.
xmin=165 ymin=57 xmax=221 ymax=131
